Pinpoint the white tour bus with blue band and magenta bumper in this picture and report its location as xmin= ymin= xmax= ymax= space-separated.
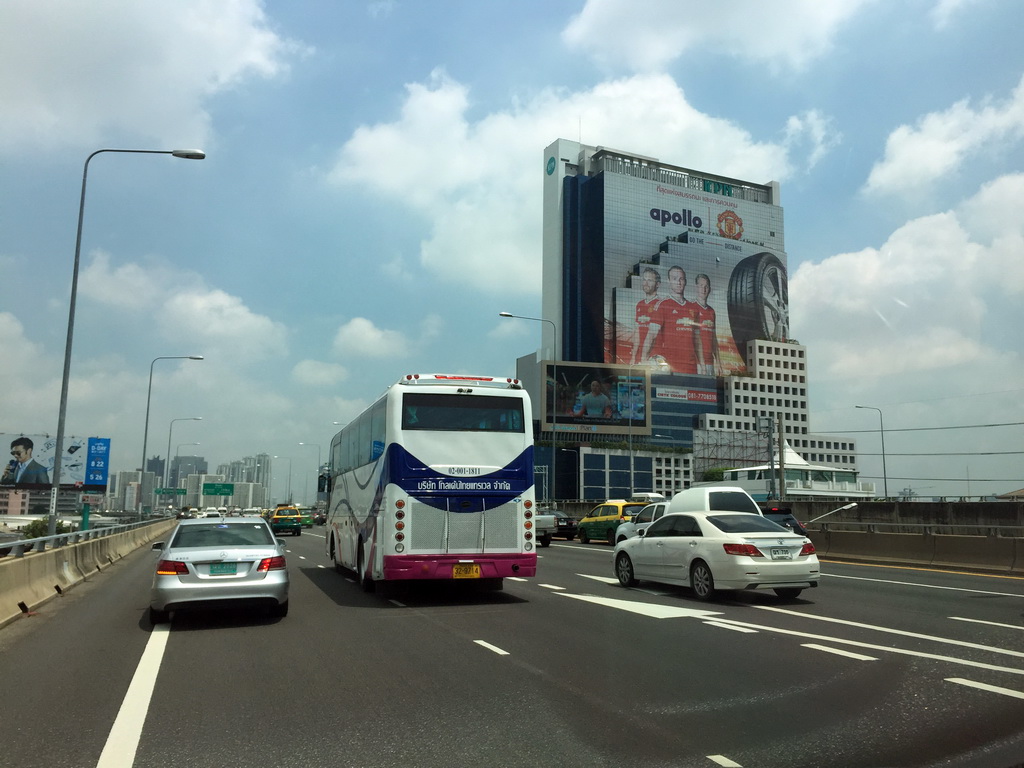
xmin=325 ymin=374 xmax=537 ymax=592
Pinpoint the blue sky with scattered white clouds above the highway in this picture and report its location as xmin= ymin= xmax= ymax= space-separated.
xmin=0 ymin=0 xmax=1024 ymax=505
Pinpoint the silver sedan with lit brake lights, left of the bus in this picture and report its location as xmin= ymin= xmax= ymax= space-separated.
xmin=150 ymin=517 xmax=289 ymax=624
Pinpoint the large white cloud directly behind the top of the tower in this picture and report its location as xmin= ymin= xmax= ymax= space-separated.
xmin=329 ymin=72 xmax=806 ymax=295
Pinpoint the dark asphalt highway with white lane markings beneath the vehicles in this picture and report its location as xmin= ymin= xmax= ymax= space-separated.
xmin=0 ymin=528 xmax=1024 ymax=768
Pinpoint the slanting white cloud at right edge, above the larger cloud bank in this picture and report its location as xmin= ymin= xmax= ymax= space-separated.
xmin=864 ymin=77 xmax=1024 ymax=196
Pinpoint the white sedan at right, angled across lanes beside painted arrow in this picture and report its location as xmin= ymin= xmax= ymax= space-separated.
xmin=614 ymin=512 xmax=821 ymax=600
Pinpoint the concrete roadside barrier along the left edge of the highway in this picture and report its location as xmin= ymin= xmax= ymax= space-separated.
xmin=0 ymin=520 xmax=177 ymax=627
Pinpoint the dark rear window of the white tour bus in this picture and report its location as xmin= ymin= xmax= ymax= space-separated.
xmin=401 ymin=392 xmax=525 ymax=433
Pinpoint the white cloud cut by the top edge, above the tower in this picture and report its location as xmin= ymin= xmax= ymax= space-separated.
xmin=562 ymin=0 xmax=871 ymax=72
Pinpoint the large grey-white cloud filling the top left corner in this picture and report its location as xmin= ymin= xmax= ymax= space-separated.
xmin=0 ymin=0 xmax=301 ymax=152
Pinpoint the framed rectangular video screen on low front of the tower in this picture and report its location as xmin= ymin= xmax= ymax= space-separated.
xmin=541 ymin=360 xmax=650 ymax=435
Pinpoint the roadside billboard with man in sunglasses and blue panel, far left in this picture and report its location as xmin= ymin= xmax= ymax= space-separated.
xmin=0 ymin=433 xmax=111 ymax=493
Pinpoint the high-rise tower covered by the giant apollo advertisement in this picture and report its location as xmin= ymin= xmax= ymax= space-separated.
xmin=517 ymin=139 xmax=855 ymax=499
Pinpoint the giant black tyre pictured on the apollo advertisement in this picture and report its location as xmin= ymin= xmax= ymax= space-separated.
xmin=728 ymin=251 xmax=790 ymax=365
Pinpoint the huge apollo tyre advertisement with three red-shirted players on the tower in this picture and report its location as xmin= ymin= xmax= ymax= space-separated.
xmin=603 ymin=173 xmax=790 ymax=376
